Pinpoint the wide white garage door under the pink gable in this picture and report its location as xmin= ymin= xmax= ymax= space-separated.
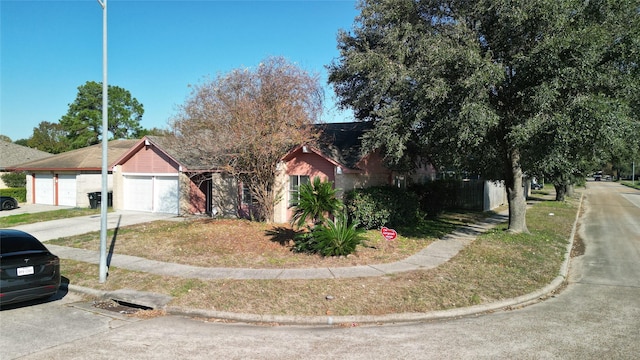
xmin=124 ymin=175 xmax=179 ymax=214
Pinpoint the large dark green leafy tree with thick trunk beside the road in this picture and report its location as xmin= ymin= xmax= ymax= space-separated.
xmin=329 ymin=0 xmax=640 ymax=232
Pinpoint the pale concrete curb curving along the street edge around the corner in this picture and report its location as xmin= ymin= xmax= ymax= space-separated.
xmin=68 ymin=194 xmax=584 ymax=326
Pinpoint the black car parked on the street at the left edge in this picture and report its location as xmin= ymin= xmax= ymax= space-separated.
xmin=0 ymin=229 xmax=60 ymax=305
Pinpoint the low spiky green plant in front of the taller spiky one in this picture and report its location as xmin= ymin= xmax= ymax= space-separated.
xmin=312 ymin=212 xmax=365 ymax=256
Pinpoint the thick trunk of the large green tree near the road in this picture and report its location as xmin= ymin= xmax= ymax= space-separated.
xmin=507 ymin=149 xmax=529 ymax=233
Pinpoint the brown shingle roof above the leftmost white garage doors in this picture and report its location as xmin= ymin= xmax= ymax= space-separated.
xmin=10 ymin=140 xmax=139 ymax=171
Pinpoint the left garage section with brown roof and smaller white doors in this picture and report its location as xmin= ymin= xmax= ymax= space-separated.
xmin=10 ymin=140 xmax=138 ymax=207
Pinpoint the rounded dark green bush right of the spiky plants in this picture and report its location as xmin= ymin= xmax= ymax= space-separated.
xmin=345 ymin=186 xmax=420 ymax=229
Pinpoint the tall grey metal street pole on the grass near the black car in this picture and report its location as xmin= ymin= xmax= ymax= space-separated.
xmin=98 ymin=0 xmax=109 ymax=283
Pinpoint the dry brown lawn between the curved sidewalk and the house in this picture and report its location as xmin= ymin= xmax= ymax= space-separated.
xmin=52 ymin=213 xmax=486 ymax=268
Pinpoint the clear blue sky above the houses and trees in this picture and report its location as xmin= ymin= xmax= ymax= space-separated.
xmin=0 ymin=0 xmax=358 ymax=141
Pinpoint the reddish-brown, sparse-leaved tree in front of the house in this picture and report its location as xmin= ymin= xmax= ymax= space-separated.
xmin=172 ymin=57 xmax=323 ymax=221
